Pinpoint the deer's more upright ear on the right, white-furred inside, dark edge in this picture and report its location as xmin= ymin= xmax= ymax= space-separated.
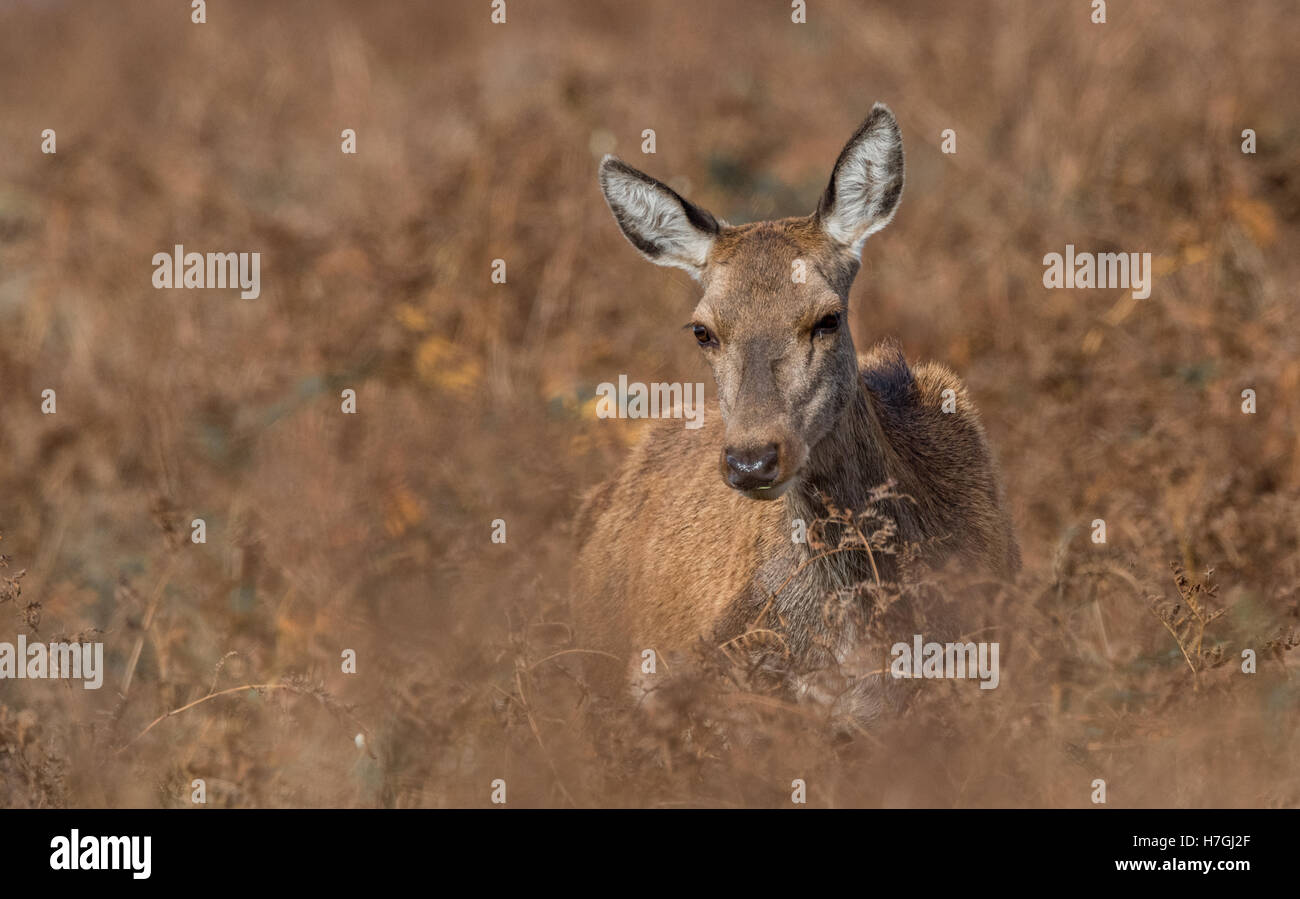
xmin=816 ymin=103 xmax=902 ymax=257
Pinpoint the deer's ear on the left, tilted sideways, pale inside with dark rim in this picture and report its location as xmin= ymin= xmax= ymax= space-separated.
xmin=601 ymin=156 xmax=722 ymax=281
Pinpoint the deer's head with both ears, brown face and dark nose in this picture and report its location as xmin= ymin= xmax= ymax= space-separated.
xmin=601 ymin=103 xmax=904 ymax=499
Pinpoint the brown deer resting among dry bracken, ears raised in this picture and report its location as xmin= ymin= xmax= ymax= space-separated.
xmin=575 ymin=103 xmax=1021 ymax=717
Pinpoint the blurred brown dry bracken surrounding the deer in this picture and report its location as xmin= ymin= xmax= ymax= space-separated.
xmin=0 ymin=0 xmax=1300 ymax=807
